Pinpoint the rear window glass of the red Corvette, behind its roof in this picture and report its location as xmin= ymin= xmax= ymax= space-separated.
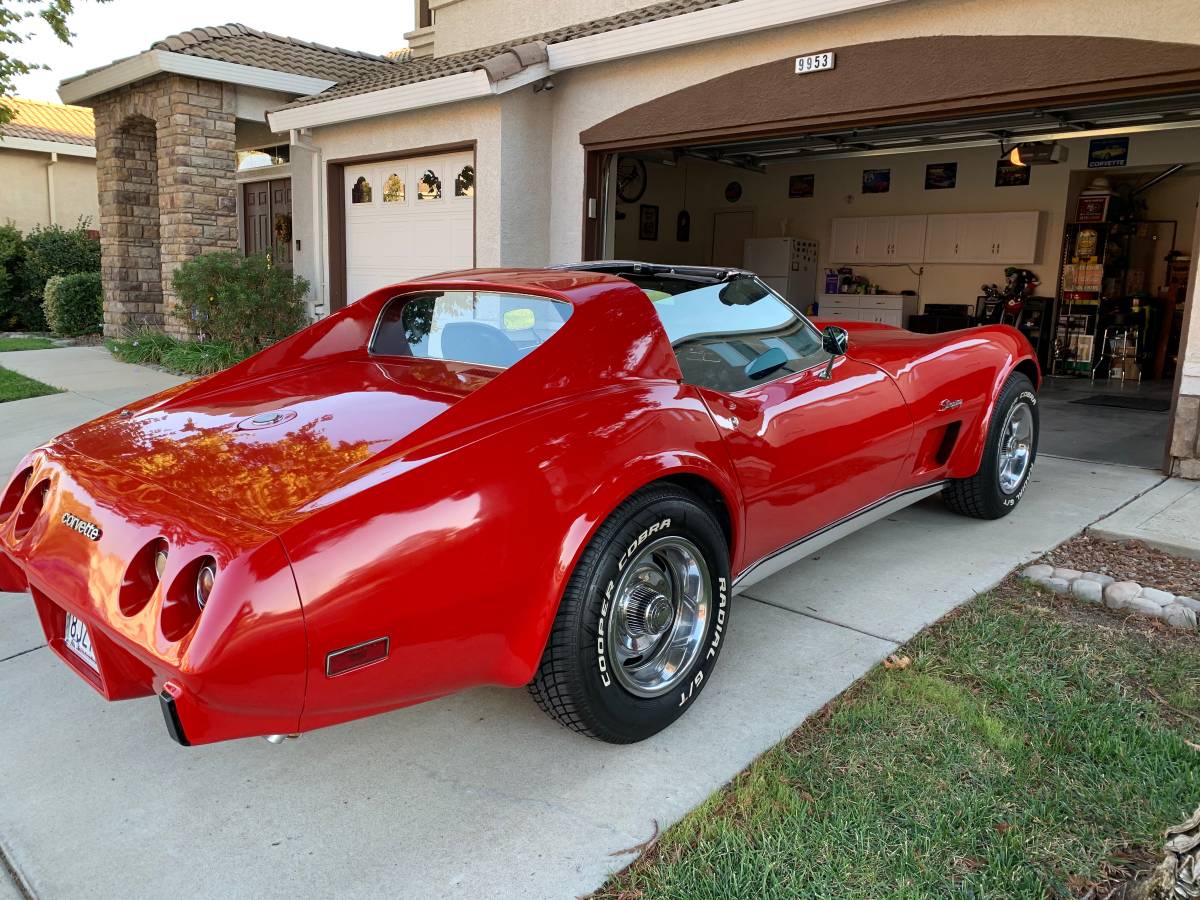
xmin=370 ymin=290 xmax=571 ymax=368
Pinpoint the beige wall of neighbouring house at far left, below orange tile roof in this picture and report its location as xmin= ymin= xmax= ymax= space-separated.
xmin=0 ymin=149 xmax=100 ymax=232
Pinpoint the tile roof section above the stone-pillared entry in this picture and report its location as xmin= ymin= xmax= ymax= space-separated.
xmin=150 ymin=23 xmax=403 ymax=82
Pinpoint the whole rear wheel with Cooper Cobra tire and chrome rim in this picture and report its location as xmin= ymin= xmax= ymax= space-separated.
xmin=529 ymin=486 xmax=730 ymax=744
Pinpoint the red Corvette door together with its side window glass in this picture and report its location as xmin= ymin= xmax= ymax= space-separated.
xmin=643 ymin=276 xmax=913 ymax=580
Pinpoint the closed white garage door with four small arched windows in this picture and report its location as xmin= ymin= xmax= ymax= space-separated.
xmin=346 ymin=151 xmax=475 ymax=301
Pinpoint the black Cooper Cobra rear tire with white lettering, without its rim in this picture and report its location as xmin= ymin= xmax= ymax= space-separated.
xmin=529 ymin=485 xmax=731 ymax=744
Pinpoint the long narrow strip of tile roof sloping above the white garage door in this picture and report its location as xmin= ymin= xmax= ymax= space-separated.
xmin=284 ymin=0 xmax=739 ymax=108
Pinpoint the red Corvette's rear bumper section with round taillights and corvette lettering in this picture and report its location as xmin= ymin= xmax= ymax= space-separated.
xmin=0 ymin=444 xmax=306 ymax=744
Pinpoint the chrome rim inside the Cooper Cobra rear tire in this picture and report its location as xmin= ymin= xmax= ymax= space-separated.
xmin=605 ymin=536 xmax=713 ymax=697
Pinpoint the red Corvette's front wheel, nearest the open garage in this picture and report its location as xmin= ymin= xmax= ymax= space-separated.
xmin=942 ymin=372 xmax=1038 ymax=518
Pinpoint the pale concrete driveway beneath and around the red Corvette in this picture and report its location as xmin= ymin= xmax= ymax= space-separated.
xmin=0 ymin=350 xmax=1162 ymax=900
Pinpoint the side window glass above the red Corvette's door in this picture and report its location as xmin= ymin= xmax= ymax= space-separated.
xmin=640 ymin=277 xmax=826 ymax=394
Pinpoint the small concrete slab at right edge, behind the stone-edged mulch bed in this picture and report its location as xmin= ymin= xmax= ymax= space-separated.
xmin=1088 ymin=478 xmax=1200 ymax=559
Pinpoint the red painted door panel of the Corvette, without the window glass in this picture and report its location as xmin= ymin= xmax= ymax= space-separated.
xmin=698 ymin=355 xmax=913 ymax=566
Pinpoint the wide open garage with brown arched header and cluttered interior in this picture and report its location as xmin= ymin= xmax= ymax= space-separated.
xmin=581 ymin=37 xmax=1200 ymax=468
